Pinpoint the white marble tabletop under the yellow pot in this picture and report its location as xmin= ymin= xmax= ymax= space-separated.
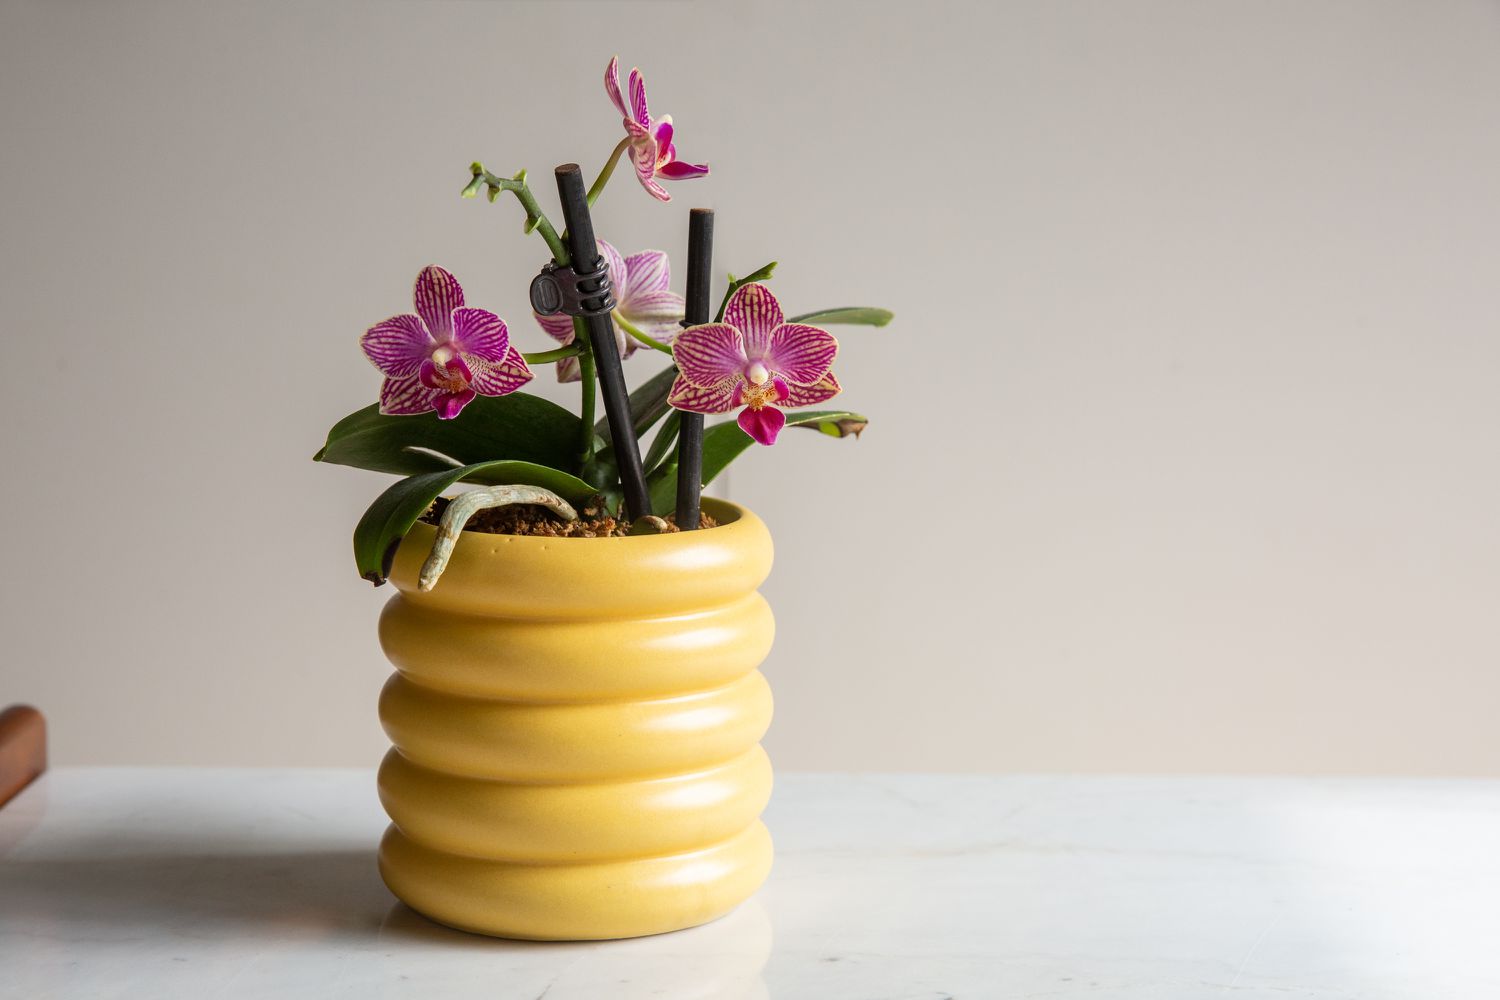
xmin=0 ymin=769 xmax=1500 ymax=1000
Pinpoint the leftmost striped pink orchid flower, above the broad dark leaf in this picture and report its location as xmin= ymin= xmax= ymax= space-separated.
xmin=360 ymin=267 xmax=531 ymax=420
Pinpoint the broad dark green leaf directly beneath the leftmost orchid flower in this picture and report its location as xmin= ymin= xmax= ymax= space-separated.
xmin=312 ymin=393 xmax=578 ymax=486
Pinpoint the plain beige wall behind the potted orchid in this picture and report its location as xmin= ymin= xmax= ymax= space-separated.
xmin=0 ymin=0 xmax=1500 ymax=775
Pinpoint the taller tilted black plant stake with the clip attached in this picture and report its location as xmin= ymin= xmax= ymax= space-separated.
xmin=557 ymin=163 xmax=651 ymax=520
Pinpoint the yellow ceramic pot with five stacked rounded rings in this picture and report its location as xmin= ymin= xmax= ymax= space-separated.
xmin=380 ymin=499 xmax=776 ymax=940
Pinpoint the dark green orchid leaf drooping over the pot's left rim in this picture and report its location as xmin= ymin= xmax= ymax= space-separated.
xmin=354 ymin=460 xmax=597 ymax=586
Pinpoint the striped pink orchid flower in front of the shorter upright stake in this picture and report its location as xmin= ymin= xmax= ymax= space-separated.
xmin=668 ymin=285 xmax=840 ymax=444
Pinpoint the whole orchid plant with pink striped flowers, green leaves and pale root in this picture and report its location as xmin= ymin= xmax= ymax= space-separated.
xmin=314 ymin=60 xmax=891 ymax=588
